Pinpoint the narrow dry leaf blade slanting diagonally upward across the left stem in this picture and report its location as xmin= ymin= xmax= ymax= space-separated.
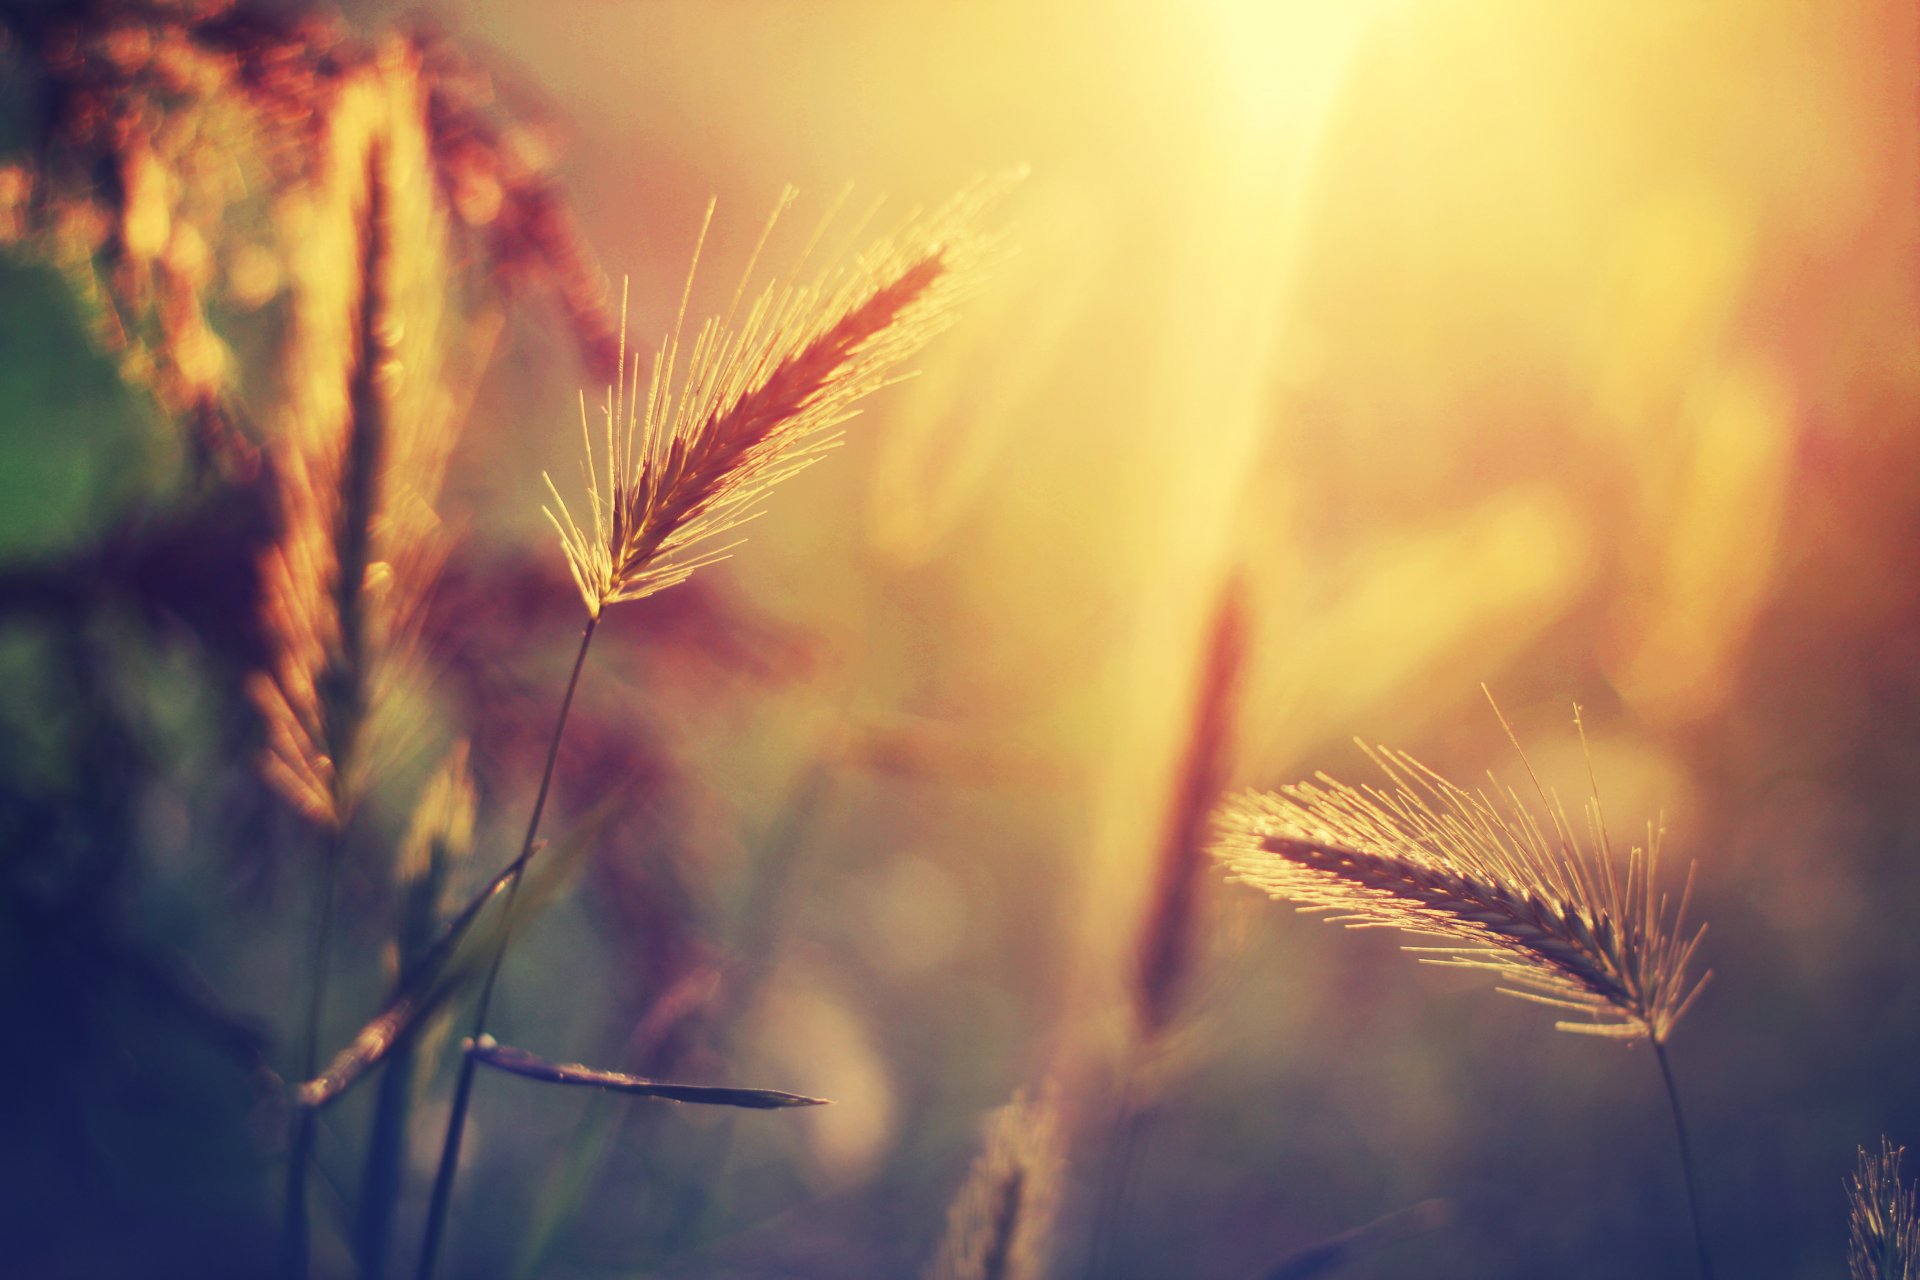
xmin=294 ymin=796 xmax=618 ymax=1109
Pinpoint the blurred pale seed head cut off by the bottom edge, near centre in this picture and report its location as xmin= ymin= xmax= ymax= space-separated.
xmin=927 ymin=1094 xmax=1064 ymax=1280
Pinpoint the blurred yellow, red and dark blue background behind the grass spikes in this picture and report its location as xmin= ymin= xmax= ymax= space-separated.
xmin=0 ymin=0 xmax=1920 ymax=1280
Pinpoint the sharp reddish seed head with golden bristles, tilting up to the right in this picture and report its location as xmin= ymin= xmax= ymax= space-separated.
xmin=547 ymin=188 xmax=991 ymax=618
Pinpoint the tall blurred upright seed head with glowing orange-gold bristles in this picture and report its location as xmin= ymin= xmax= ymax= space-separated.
xmin=250 ymin=48 xmax=451 ymax=825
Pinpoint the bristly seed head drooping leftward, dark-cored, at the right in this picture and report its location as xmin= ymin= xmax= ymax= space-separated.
xmin=1213 ymin=721 xmax=1705 ymax=1044
